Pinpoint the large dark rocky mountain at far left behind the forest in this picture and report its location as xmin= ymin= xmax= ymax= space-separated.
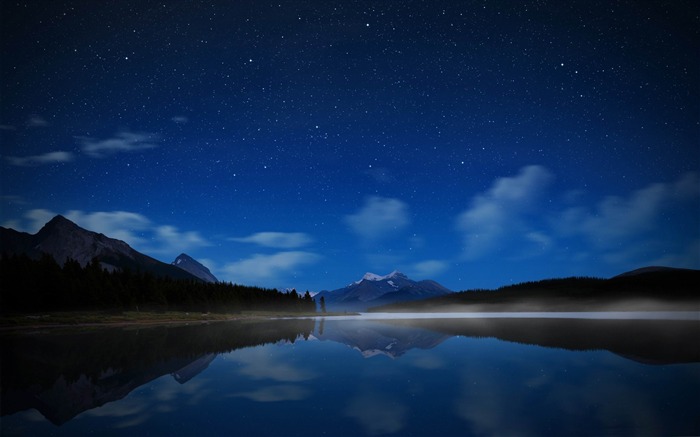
xmin=0 ymin=215 xmax=199 ymax=280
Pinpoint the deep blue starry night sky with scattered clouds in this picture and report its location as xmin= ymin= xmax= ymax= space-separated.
xmin=0 ymin=0 xmax=700 ymax=291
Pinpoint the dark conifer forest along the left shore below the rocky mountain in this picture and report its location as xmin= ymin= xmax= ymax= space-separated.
xmin=0 ymin=255 xmax=316 ymax=313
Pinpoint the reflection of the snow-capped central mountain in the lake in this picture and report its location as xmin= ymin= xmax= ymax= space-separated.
xmin=314 ymin=320 xmax=450 ymax=358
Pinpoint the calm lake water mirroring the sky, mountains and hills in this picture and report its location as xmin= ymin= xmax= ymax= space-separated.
xmin=0 ymin=317 xmax=700 ymax=436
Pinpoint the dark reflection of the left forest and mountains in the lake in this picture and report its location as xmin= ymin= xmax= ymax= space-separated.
xmin=0 ymin=320 xmax=314 ymax=425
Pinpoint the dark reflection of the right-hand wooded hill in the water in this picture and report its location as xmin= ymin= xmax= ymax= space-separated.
xmin=374 ymin=318 xmax=700 ymax=364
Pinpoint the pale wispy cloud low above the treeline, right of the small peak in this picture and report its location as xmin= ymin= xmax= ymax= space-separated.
xmin=217 ymin=251 xmax=321 ymax=286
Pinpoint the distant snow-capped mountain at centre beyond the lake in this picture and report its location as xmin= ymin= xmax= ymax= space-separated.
xmin=314 ymin=270 xmax=452 ymax=311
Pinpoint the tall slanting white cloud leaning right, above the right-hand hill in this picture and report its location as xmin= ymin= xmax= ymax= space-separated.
xmin=457 ymin=165 xmax=552 ymax=260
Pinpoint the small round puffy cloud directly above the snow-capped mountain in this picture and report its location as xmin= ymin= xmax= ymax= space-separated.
xmin=345 ymin=196 xmax=410 ymax=241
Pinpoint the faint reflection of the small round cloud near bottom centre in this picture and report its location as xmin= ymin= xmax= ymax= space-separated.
xmin=345 ymin=391 xmax=408 ymax=435
